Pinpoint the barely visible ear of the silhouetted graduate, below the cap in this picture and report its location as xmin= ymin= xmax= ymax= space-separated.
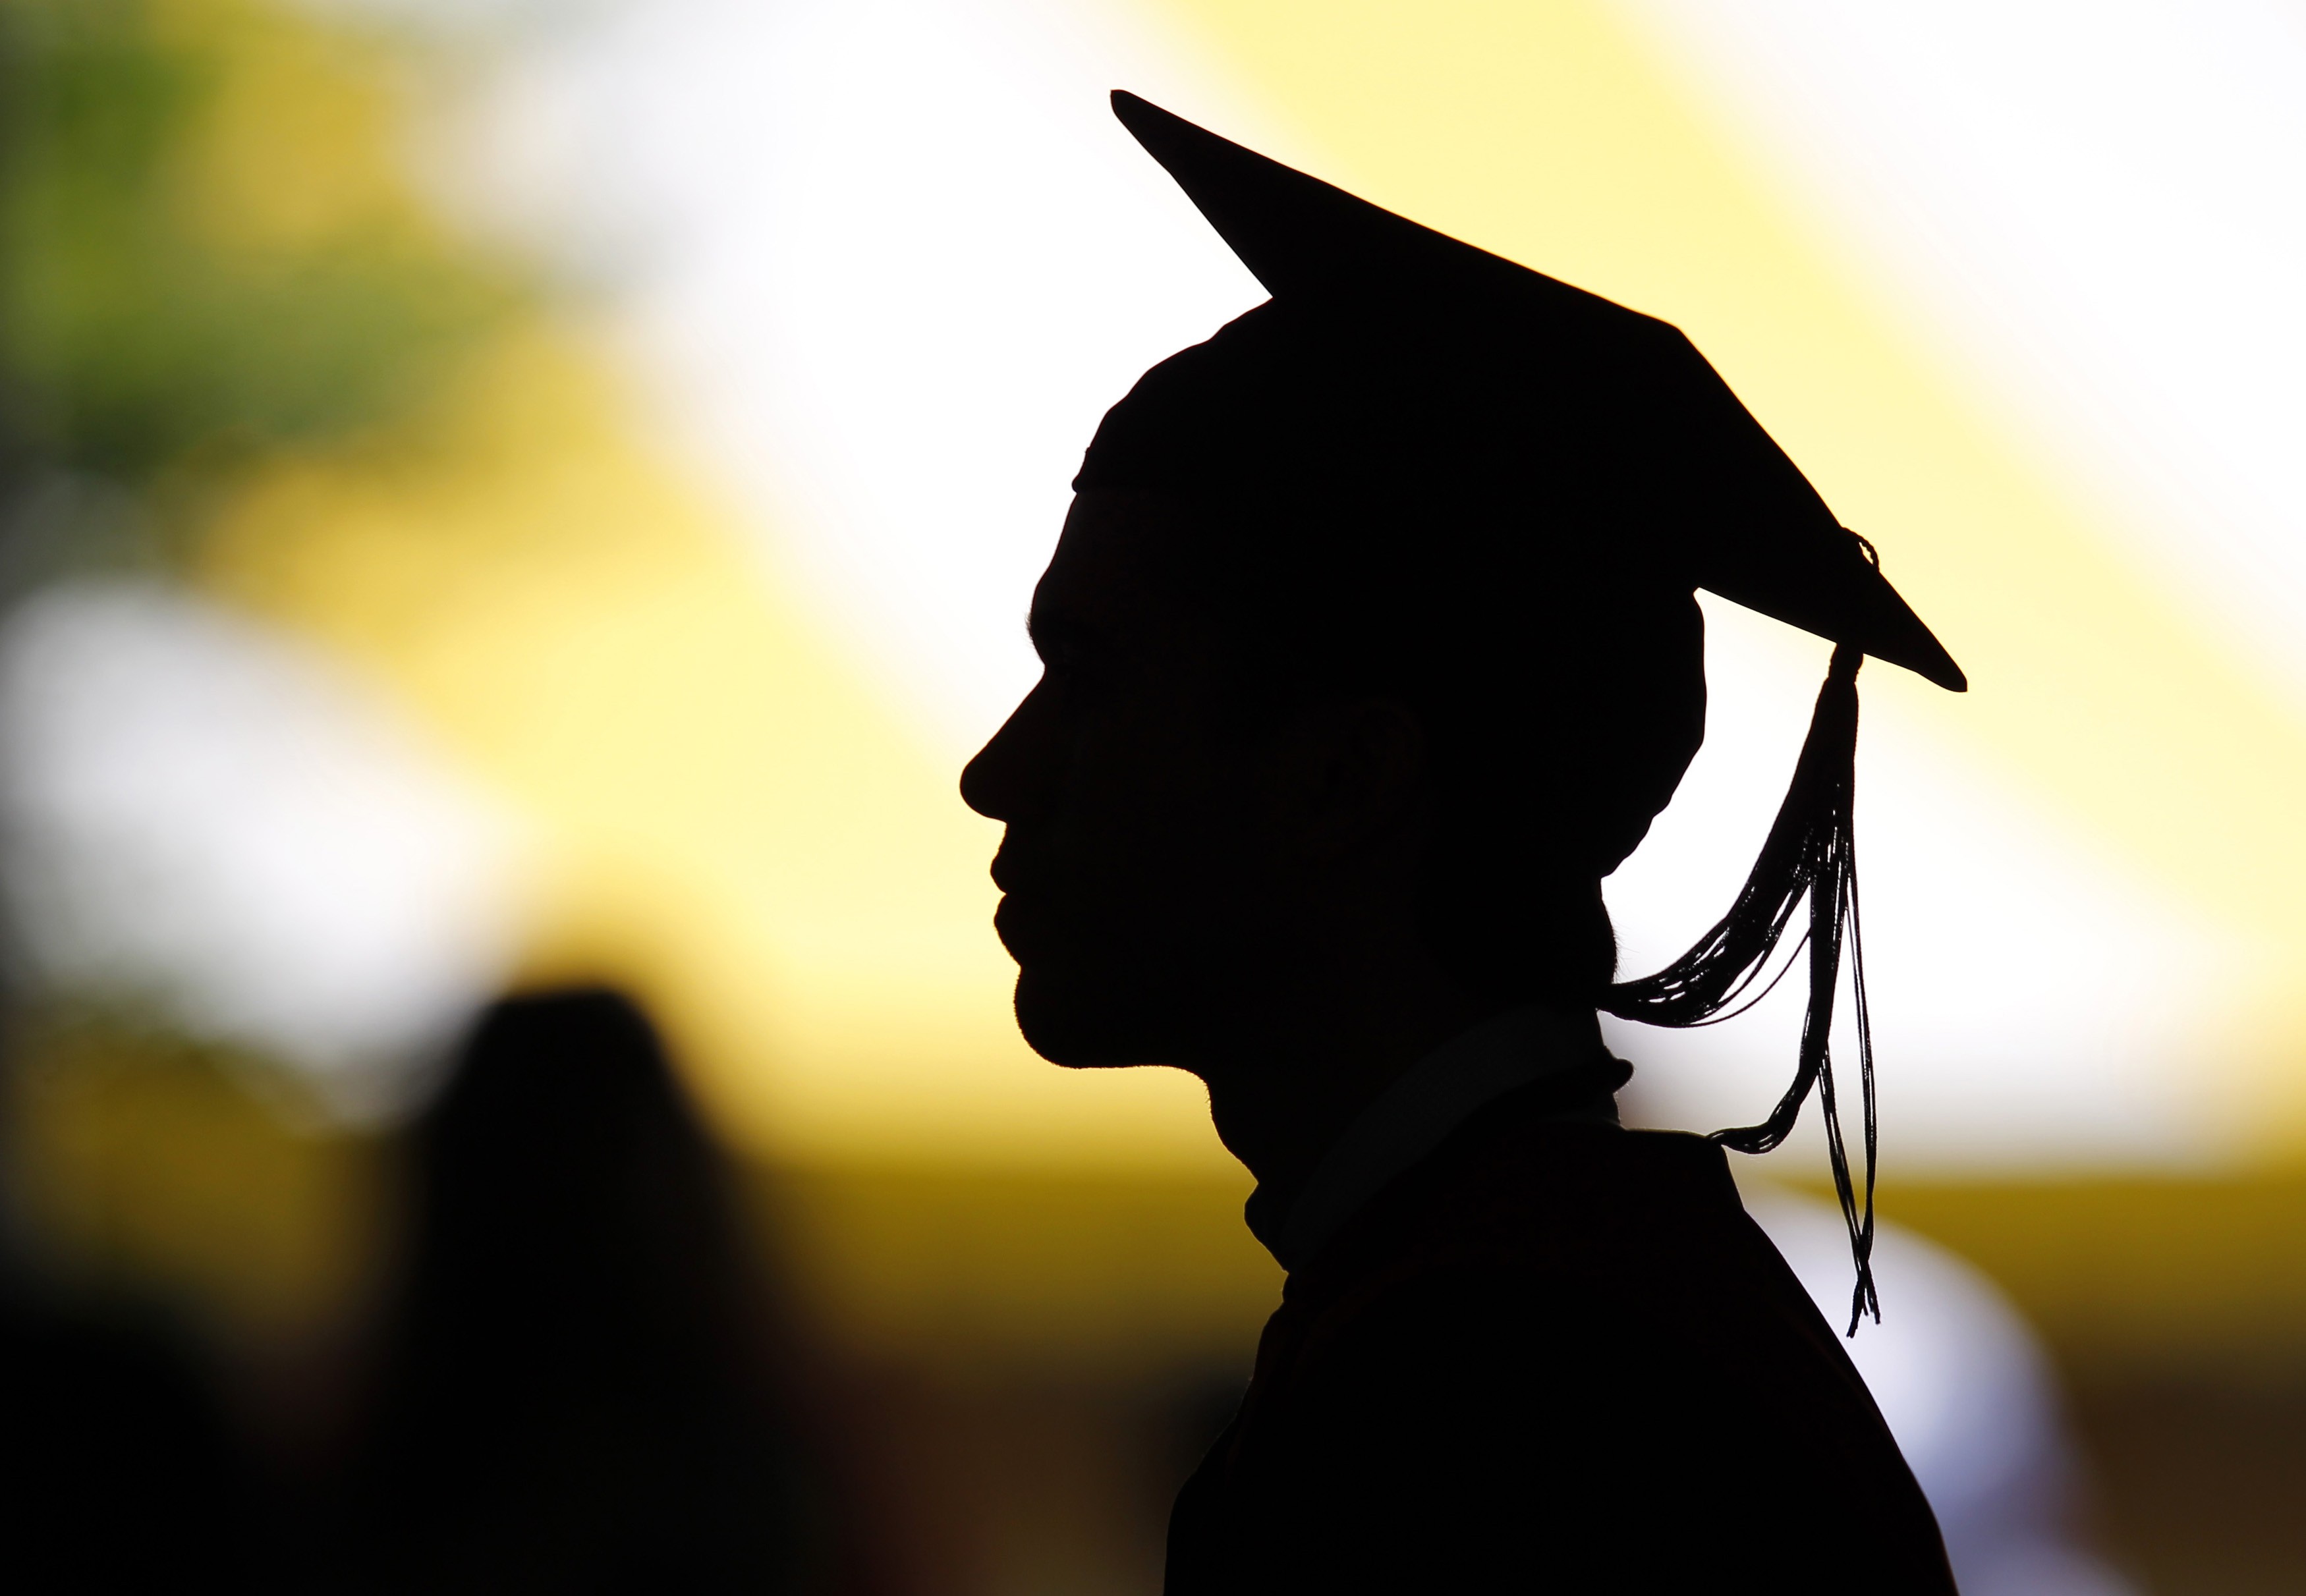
xmin=1264 ymin=696 xmax=1425 ymax=858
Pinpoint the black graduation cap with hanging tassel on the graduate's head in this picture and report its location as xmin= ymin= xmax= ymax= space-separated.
xmin=1075 ymin=92 xmax=1967 ymax=1331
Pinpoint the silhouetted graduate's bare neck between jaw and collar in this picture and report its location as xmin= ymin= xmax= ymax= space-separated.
xmin=1195 ymin=971 xmax=1502 ymax=1209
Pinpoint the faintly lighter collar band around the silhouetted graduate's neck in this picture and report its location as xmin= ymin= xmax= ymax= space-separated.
xmin=1248 ymin=1008 xmax=1617 ymax=1269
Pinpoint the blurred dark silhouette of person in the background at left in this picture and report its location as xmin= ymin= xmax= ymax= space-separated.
xmin=341 ymin=992 xmax=835 ymax=1596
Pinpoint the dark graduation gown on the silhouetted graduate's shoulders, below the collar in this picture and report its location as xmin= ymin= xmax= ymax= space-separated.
xmin=1167 ymin=1063 xmax=1954 ymax=1596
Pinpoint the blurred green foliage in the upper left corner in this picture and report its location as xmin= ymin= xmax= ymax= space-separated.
xmin=0 ymin=0 xmax=521 ymax=555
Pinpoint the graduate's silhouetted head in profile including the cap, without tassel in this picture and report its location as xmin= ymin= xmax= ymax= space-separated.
xmin=964 ymin=95 xmax=1963 ymax=1063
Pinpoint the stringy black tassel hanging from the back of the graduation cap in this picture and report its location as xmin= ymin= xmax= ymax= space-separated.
xmin=1603 ymin=644 xmax=1882 ymax=1335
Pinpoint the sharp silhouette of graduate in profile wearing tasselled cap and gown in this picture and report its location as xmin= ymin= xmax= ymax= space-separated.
xmin=962 ymin=95 xmax=1963 ymax=1596
